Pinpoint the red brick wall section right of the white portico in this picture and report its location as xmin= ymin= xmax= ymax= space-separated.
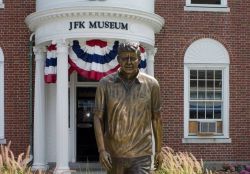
xmin=155 ymin=0 xmax=250 ymax=160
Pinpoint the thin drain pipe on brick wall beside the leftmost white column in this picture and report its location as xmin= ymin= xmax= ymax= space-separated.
xmin=29 ymin=33 xmax=35 ymax=165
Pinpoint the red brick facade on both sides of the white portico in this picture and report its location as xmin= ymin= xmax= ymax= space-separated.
xmin=0 ymin=0 xmax=250 ymax=160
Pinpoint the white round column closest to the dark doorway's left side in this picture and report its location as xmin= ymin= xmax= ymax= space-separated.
xmin=55 ymin=40 xmax=69 ymax=173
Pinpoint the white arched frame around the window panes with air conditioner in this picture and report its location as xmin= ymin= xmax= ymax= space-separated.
xmin=182 ymin=38 xmax=231 ymax=143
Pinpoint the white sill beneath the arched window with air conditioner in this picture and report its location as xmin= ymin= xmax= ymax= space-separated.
xmin=182 ymin=138 xmax=232 ymax=144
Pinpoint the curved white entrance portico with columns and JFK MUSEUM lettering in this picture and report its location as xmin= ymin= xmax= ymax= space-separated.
xmin=25 ymin=0 xmax=164 ymax=173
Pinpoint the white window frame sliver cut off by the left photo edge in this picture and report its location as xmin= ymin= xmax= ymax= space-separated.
xmin=0 ymin=47 xmax=6 ymax=144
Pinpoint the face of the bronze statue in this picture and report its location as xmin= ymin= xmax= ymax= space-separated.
xmin=118 ymin=52 xmax=140 ymax=74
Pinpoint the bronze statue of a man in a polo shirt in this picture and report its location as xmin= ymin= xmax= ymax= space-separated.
xmin=94 ymin=43 xmax=162 ymax=174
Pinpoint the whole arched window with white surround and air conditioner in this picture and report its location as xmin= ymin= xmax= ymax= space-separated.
xmin=183 ymin=38 xmax=231 ymax=143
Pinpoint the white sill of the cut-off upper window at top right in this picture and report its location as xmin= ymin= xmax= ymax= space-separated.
xmin=184 ymin=6 xmax=230 ymax=13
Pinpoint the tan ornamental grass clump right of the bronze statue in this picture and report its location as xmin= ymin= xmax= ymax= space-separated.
xmin=155 ymin=147 xmax=212 ymax=174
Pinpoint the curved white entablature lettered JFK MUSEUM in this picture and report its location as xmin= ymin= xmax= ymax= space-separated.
xmin=25 ymin=1 xmax=164 ymax=47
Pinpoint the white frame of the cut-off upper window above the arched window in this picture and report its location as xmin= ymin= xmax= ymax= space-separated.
xmin=184 ymin=0 xmax=230 ymax=12
